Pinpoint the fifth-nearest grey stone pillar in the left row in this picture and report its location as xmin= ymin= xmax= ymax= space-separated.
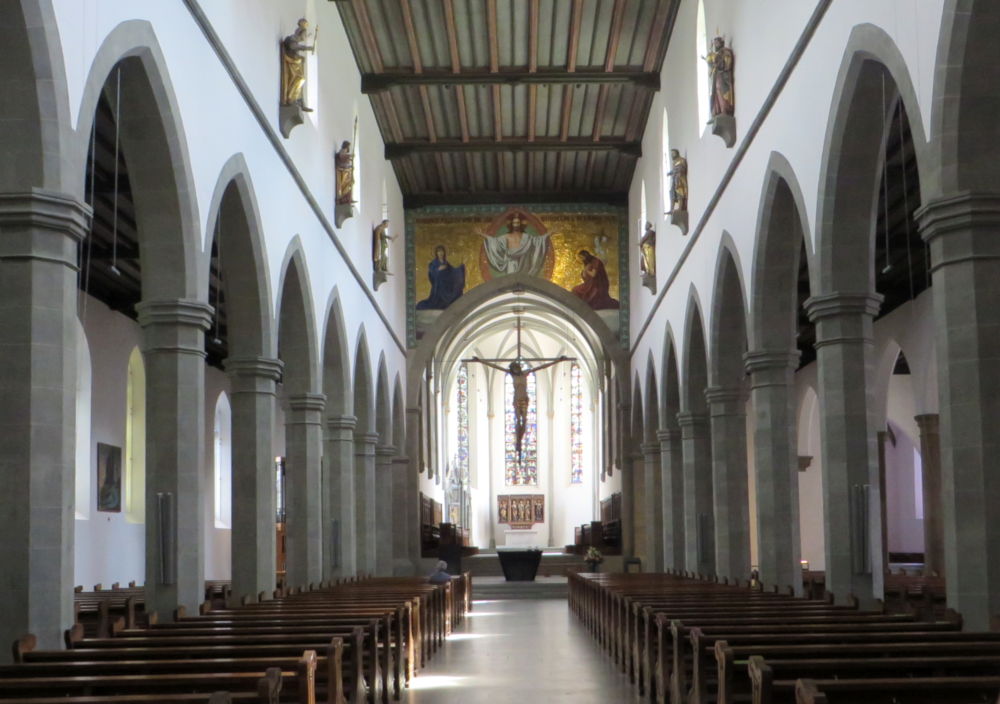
xmin=323 ymin=416 xmax=358 ymax=579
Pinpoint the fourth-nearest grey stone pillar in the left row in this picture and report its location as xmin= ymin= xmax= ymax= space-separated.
xmin=285 ymin=393 xmax=326 ymax=587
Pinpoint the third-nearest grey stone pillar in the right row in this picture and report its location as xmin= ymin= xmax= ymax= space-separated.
xmin=744 ymin=350 xmax=802 ymax=595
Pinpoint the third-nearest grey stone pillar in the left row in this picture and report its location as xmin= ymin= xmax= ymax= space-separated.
xmin=226 ymin=357 xmax=287 ymax=599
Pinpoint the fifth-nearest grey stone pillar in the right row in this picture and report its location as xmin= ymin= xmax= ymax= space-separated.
xmin=677 ymin=411 xmax=715 ymax=575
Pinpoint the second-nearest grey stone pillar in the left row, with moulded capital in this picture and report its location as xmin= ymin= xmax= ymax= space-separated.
xmin=136 ymin=300 xmax=213 ymax=619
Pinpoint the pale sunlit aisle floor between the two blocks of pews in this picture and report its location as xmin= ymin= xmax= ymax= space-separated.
xmin=403 ymin=599 xmax=638 ymax=704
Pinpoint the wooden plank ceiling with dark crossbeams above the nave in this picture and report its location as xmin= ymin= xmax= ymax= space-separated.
xmin=334 ymin=0 xmax=679 ymax=207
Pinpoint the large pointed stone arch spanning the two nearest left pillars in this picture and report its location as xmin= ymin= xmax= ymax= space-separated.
xmin=70 ymin=20 xmax=199 ymax=301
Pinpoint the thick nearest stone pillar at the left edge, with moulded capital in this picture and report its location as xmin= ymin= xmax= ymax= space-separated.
xmin=0 ymin=190 xmax=90 ymax=662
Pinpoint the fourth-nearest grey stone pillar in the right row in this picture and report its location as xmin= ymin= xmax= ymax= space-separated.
xmin=705 ymin=387 xmax=752 ymax=586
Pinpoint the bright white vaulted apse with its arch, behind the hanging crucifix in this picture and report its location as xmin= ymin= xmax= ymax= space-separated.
xmin=407 ymin=274 xmax=627 ymax=560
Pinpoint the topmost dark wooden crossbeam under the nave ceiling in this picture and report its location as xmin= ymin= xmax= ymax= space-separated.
xmin=361 ymin=67 xmax=660 ymax=94
